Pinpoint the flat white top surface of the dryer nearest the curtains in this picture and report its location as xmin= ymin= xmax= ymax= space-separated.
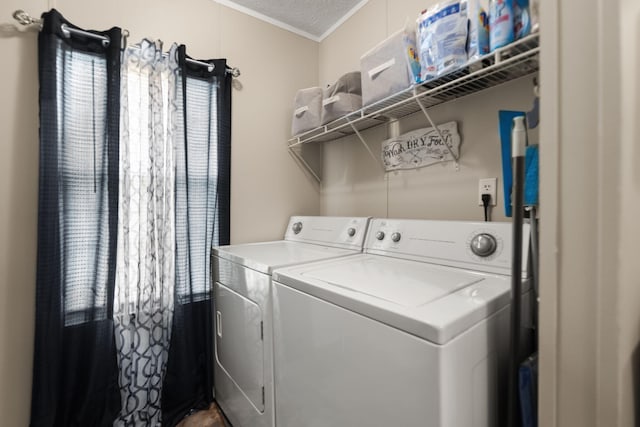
xmin=213 ymin=240 xmax=360 ymax=274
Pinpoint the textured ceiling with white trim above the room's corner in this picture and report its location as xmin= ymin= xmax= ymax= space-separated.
xmin=214 ymin=0 xmax=368 ymax=41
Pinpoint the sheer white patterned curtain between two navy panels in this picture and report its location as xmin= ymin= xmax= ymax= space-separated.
xmin=114 ymin=40 xmax=181 ymax=426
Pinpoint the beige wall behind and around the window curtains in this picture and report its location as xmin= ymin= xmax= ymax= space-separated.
xmin=0 ymin=0 xmax=319 ymax=426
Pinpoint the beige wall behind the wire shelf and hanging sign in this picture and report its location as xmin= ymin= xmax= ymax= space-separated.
xmin=319 ymin=0 xmax=536 ymax=221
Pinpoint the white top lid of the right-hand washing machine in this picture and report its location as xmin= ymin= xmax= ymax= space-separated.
xmin=274 ymin=254 xmax=510 ymax=344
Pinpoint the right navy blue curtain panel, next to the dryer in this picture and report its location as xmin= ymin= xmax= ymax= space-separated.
xmin=162 ymin=46 xmax=231 ymax=425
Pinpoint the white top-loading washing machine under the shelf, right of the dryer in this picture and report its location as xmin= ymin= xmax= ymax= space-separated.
xmin=273 ymin=219 xmax=529 ymax=427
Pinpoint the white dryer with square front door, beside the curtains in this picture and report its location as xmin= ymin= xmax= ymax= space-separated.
xmin=213 ymin=217 xmax=369 ymax=427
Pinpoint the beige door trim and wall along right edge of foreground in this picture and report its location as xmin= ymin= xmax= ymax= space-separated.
xmin=539 ymin=0 xmax=640 ymax=427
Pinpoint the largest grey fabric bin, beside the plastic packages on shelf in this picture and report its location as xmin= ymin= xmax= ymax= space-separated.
xmin=360 ymin=28 xmax=420 ymax=105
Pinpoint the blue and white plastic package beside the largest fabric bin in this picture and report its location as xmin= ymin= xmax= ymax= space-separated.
xmin=418 ymin=0 xmax=468 ymax=81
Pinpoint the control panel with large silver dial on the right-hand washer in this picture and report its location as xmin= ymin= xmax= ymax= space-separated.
xmin=365 ymin=219 xmax=529 ymax=276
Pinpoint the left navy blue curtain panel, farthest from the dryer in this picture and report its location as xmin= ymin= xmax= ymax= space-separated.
xmin=31 ymin=10 xmax=121 ymax=427
